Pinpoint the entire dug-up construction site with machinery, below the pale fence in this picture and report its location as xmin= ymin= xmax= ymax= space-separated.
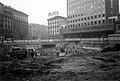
xmin=0 ymin=43 xmax=120 ymax=81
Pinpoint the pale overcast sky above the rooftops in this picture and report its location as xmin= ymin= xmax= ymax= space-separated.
xmin=0 ymin=0 xmax=67 ymax=25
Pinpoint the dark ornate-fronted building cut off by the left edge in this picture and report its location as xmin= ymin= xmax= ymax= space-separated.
xmin=0 ymin=3 xmax=13 ymax=39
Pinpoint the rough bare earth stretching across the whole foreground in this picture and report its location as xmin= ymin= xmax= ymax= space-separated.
xmin=0 ymin=52 xmax=120 ymax=81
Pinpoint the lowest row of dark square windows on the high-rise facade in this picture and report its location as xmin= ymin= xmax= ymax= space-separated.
xmin=68 ymin=20 xmax=105 ymax=27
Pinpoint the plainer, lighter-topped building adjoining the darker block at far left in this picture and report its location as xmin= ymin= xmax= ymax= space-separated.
xmin=13 ymin=9 xmax=29 ymax=40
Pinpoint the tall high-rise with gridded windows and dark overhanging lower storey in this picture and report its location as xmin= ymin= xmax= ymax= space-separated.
xmin=62 ymin=0 xmax=119 ymax=38
